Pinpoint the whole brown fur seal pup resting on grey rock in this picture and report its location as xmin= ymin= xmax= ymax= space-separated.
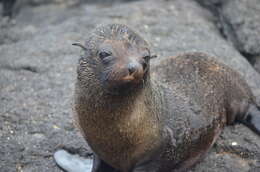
xmin=53 ymin=24 xmax=260 ymax=172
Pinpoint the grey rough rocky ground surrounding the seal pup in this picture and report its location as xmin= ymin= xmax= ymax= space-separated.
xmin=0 ymin=0 xmax=260 ymax=172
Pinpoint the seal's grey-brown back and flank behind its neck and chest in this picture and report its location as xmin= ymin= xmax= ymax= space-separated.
xmin=148 ymin=53 xmax=260 ymax=171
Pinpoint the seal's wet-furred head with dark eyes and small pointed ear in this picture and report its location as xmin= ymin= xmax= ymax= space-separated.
xmin=75 ymin=24 xmax=155 ymax=94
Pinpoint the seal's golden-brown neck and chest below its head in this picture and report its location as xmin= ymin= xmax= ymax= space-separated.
xmin=76 ymin=75 xmax=164 ymax=169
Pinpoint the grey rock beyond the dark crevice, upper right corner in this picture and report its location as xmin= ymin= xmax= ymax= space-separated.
xmin=197 ymin=0 xmax=260 ymax=60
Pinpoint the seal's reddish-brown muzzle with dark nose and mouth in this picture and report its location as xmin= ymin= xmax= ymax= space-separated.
xmin=101 ymin=53 xmax=149 ymax=95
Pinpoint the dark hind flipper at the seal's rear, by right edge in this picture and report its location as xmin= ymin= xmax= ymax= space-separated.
xmin=240 ymin=105 xmax=260 ymax=136
